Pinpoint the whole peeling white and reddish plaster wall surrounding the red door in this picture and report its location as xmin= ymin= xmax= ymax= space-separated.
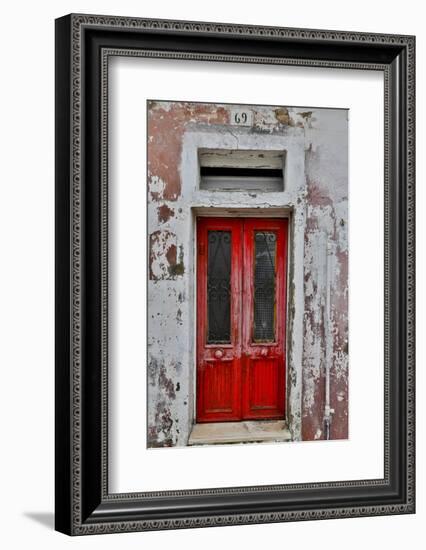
xmin=148 ymin=102 xmax=348 ymax=447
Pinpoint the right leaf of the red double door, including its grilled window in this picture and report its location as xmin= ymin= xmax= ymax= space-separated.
xmin=242 ymin=218 xmax=288 ymax=420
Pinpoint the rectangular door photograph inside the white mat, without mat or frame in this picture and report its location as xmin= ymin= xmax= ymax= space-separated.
xmin=148 ymin=100 xmax=350 ymax=448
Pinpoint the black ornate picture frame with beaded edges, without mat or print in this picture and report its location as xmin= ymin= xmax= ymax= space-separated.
xmin=55 ymin=14 xmax=415 ymax=535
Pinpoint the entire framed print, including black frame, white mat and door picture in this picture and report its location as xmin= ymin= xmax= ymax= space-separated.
xmin=56 ymin=15 xmax=415 ymax=535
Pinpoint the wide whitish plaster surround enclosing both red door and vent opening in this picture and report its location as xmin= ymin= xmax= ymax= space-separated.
xmin=181 ymin=127 xmax=307 ymax=441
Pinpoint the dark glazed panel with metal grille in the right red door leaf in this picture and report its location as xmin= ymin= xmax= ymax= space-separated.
xmin=253 ymin=231 xmax=277 ymax=342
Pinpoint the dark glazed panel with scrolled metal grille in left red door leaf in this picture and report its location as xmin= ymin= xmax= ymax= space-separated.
xmin=207 ymin=231 xmax=231 ymax=344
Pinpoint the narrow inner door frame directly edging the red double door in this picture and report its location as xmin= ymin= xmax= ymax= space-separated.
xmin=192 ymin=211 xmax=294 ymax=429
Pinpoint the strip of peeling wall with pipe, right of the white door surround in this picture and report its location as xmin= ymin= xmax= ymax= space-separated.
xmin=302 ymin=109 xmax=348 ymax=439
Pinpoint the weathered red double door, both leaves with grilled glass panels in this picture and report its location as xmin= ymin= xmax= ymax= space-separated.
xmin=197 ymin=218 xmax=288 ymax=422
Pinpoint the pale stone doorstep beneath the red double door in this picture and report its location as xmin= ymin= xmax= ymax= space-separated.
xmin=188 ymin=420 xmax=291 ymax=445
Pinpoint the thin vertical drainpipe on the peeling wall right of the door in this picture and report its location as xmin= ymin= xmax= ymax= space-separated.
xmin=324 ymin=239 xmax=335 ymax=439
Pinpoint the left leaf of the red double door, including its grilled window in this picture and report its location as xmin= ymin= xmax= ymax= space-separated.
xmin=197 ymin=218 xmax=242 ymax=422
